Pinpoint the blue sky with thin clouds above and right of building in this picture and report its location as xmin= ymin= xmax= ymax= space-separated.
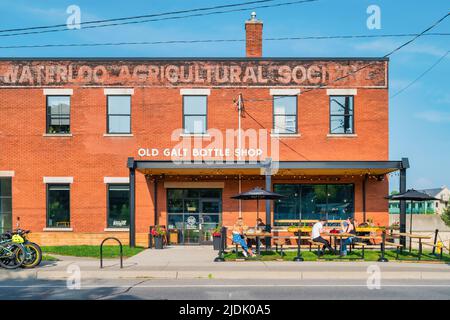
xmin=0 ymin=0 xmax=450 ymax=190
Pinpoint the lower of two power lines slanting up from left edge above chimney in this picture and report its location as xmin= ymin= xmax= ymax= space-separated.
xmin=0 ymin=0 xmax=320 ymax=37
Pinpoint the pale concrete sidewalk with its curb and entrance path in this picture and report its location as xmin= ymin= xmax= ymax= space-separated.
xmin=0 ymin=246 xmax=450 ymax=280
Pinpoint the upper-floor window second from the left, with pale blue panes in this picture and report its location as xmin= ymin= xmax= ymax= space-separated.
xmin=107 ymin=95 xmax=131 ymax=134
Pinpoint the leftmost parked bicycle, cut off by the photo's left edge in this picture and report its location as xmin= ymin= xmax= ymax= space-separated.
xmin=0 ymin=233 xmax=26 ymax=269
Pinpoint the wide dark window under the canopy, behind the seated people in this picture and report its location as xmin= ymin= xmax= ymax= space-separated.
xmin=274 ymin=184 xmax=354 ymax=225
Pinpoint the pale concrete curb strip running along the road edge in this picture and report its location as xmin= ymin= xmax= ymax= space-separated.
xmin=0 ymin=270 xmax=450 ymax=280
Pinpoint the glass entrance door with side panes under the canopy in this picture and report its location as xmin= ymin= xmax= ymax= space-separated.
xmin=167 ymin=189 xmax=222 ymax=244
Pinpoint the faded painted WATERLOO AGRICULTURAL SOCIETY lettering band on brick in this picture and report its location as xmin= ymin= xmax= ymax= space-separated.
xmin=0 ymin=60 xmax=386 ymax=87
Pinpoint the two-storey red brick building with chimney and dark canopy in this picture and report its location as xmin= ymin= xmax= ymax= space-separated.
xmin=0 ymin=14 xmax=408 ymax=245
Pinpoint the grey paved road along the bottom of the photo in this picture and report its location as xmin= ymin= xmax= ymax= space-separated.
xmin=0 ymin=279 xmax=450 ymax=300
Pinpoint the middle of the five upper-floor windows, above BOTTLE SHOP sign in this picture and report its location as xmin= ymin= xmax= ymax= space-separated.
xmin=183 ymin=96 xmax=207 ymax=134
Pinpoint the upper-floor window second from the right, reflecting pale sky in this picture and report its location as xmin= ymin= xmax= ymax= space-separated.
xmin=273 ymin=96 xmax=297 ymax=134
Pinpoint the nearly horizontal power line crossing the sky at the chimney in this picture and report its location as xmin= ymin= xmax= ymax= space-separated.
xmin=0 ymin=33 xmax=450 ymax=49
